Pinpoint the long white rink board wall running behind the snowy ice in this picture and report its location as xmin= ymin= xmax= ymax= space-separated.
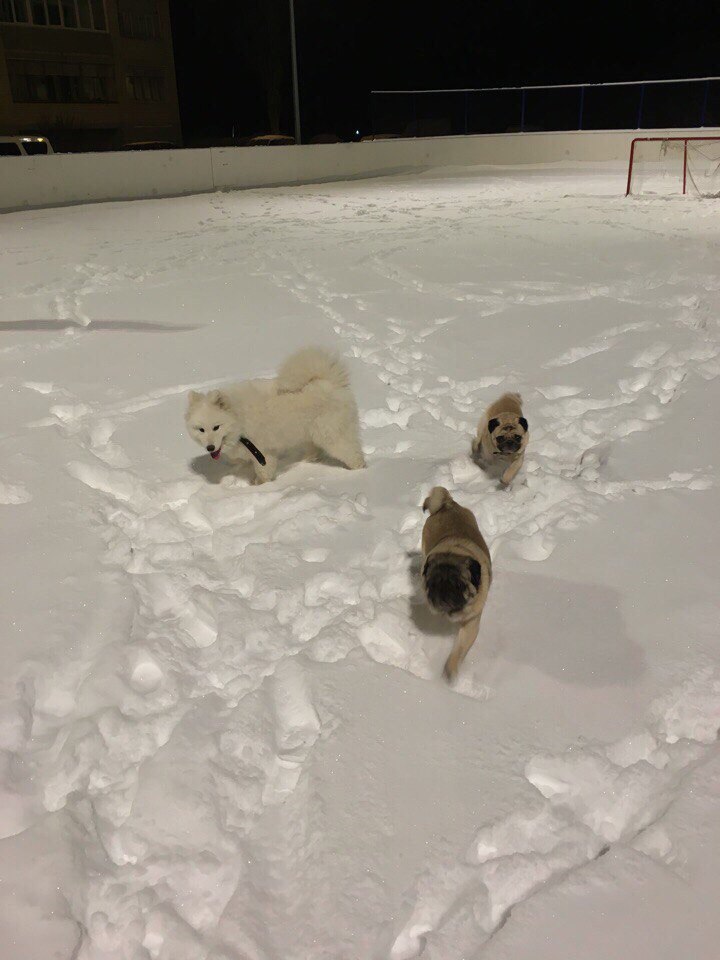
xmin=0 ymin=127 xmax=720 ymax=212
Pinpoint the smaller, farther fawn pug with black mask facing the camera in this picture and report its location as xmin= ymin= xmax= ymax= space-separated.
xmin=472 ymin=393 xmax=530 ymax=487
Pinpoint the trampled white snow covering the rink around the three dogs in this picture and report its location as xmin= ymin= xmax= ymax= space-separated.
xmin=0 ymin=166 xmax=720 ymax=960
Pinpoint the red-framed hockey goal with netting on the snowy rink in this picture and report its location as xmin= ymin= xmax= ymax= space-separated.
xmin=625 ymin=137 xmax=720 ymax=197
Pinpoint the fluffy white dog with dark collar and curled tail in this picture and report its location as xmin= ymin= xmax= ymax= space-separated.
xmin=185 ymin=347 xmax=365 ymax=483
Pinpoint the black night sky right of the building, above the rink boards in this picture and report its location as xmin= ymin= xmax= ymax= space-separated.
xmin=171 ymin=0 xmax=720 ymax=142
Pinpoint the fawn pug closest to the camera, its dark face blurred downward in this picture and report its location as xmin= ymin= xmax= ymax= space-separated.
xmin=422 ymin=487 xmax=492 ymax=683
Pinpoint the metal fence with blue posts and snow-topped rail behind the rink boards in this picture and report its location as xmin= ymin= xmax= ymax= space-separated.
xmin=371 ymin=77 xmax=720 ymax=137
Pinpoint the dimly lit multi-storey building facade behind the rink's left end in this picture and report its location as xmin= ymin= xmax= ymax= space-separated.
xmin=0 ymin=0 xmax=181 ymax=151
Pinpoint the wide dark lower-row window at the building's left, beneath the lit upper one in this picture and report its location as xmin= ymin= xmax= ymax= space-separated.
xmin=8 ymin=60 xmax=115 ymax=103
